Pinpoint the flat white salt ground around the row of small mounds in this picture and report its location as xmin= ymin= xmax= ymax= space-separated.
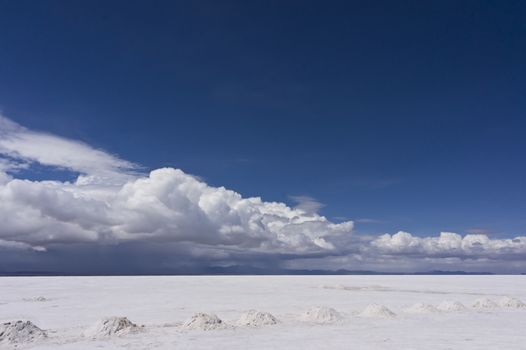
xmin=0 ymin=276 xmax=526 ymax=350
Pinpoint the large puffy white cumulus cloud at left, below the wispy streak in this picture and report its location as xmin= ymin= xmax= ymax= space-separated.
xmin=0 ymin=168 xmax=353 ymax=253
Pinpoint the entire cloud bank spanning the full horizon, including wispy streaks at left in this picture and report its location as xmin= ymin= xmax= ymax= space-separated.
xmin=0 ymin=116 xmax=526 ymax=270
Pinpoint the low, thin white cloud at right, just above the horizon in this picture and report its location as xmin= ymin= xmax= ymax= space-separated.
xmin=285 ymin=231 xmax=526 ymax=273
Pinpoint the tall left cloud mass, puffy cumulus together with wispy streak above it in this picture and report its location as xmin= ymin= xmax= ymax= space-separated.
xmin=0 ymin=118 xmax=353 ymax=264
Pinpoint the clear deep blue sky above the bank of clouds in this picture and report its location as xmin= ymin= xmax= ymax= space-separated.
xmin=0 ymin=1 xmax=526 ymax=237
